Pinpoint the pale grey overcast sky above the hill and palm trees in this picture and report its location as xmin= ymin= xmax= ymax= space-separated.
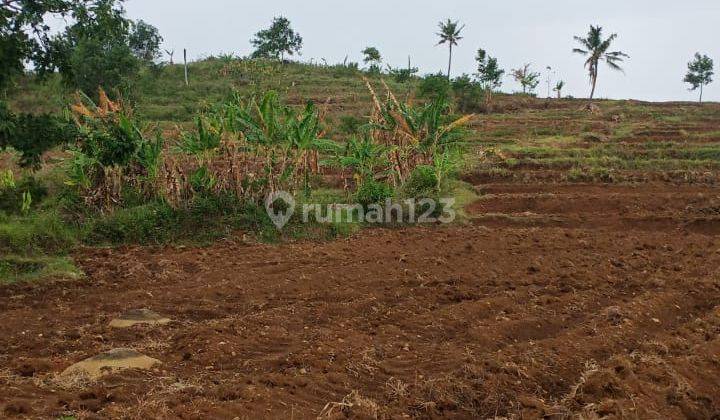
xmin=116 ymin=0 xmax=720 ymax=101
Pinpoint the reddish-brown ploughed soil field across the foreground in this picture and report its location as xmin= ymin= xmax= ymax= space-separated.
xmin=0 ymin=184 xmax=720 ymax=419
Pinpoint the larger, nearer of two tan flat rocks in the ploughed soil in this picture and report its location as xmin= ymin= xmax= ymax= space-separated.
xmin=61 ymin=348 xmax=162 ymax=379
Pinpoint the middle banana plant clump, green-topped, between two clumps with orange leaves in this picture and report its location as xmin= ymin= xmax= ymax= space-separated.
xmin=162 ymin=91 xmax=330 ymax=206
